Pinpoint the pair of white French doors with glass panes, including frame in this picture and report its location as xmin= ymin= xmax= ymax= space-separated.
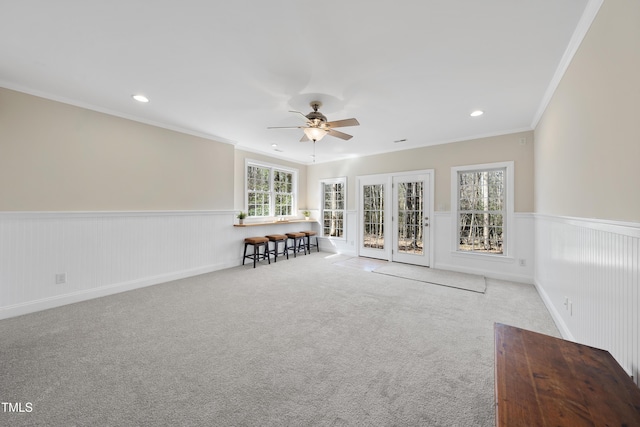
xmin=358 ymin=171 xmax=433 ymax=266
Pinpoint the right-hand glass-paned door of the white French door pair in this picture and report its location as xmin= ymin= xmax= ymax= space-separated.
xmin=391 ymin=174 xmax=431 ymax=266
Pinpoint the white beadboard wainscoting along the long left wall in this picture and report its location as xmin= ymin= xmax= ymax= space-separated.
xmin=0 ymin=211 xmax=241 ymax=318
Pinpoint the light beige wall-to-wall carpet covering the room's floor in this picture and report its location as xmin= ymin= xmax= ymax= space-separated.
xmin=0 ymin=253 xmax=558 ymax=426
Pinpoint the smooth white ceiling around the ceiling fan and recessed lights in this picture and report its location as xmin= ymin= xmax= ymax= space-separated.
xmin=0 ymin=0 xmax=589 ymax=163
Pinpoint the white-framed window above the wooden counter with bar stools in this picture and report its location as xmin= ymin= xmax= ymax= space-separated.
xmin=246 ymin=161 xmax=298 ymax=217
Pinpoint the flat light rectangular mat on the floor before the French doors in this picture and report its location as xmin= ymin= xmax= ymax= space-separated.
xmin=373 ymin=262 xmax=487 ymax=294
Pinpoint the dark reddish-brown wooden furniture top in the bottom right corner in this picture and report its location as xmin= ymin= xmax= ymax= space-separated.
xmin=494 ymin=323 xmax=640 ymax=427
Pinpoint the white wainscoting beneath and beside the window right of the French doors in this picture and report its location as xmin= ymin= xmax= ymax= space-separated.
xmin=431 ymin=211 xmax=535 ymax=283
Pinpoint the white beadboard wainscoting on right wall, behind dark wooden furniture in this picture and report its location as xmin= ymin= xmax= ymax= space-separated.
xmin=535 ymin=214 xmax=640 ymax=385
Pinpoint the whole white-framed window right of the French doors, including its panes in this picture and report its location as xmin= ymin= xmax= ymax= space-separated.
xmin=451 ymin=162 xmax=513 ymax=255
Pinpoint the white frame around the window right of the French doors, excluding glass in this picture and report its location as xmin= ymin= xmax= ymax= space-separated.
xmin=451 ymin=161 xmax=515 ymax=261
